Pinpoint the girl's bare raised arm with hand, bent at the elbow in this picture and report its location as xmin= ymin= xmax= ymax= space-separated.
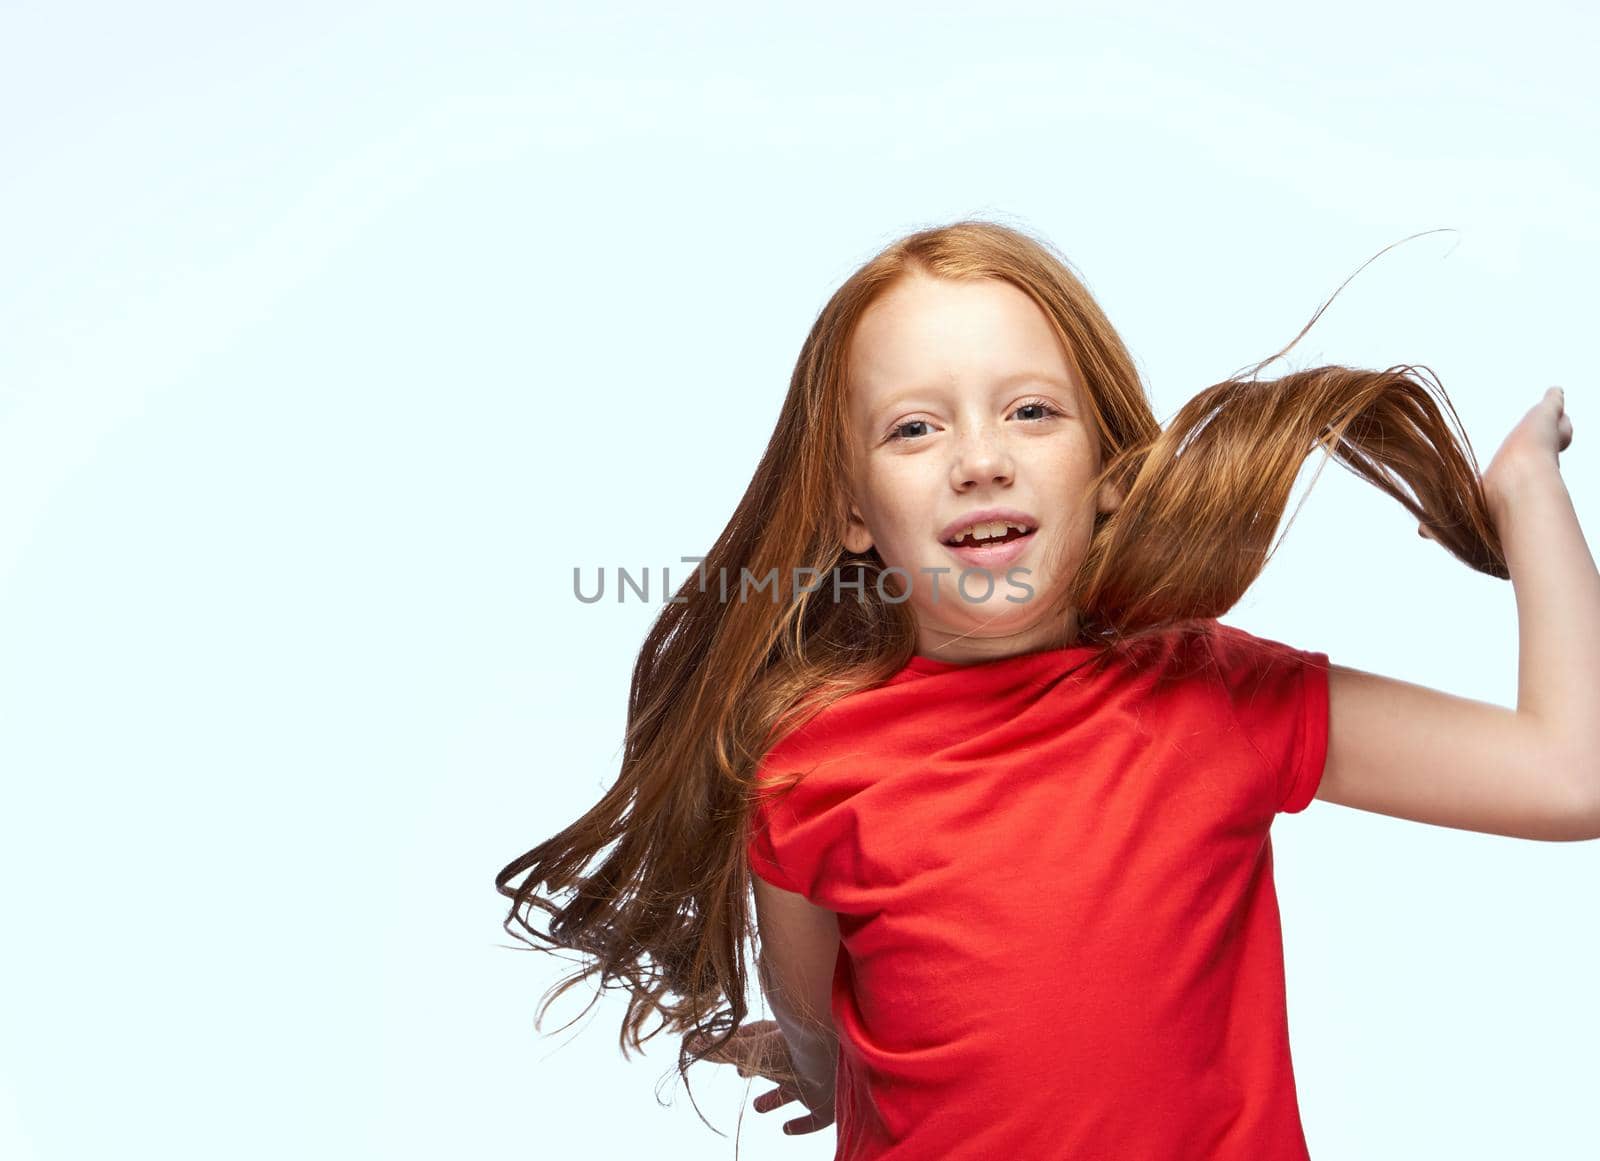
xmin=1317 ymin=389 xmax=1600 ymax=841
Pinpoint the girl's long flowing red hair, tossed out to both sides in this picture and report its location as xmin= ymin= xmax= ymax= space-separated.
xmin=494 ymin=221 xmax=1509 ymax=1125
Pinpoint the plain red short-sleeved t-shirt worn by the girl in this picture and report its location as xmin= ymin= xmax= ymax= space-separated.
xmin=747 ymin=619 xmax=1328 ymax=1161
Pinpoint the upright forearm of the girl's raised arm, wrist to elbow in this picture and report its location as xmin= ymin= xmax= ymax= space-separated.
xmin=1491 ymin=464 xmax=1600 ymax=804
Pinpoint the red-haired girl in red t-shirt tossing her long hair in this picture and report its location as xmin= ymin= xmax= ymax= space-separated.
xmin=496 ymin=221 xmax=1600 ymax=1161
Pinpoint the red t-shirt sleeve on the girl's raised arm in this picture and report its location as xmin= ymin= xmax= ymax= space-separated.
xmin=1213 ymin=622 xmax=1328 ymax=814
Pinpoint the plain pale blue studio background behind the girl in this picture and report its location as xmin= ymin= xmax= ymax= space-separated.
xmin=0 ymin=0 xmax=1600 ymax=1161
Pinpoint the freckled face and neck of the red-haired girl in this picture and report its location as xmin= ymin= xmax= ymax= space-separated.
xmin=845 ymin=267 xmax=1117 ymax=662
